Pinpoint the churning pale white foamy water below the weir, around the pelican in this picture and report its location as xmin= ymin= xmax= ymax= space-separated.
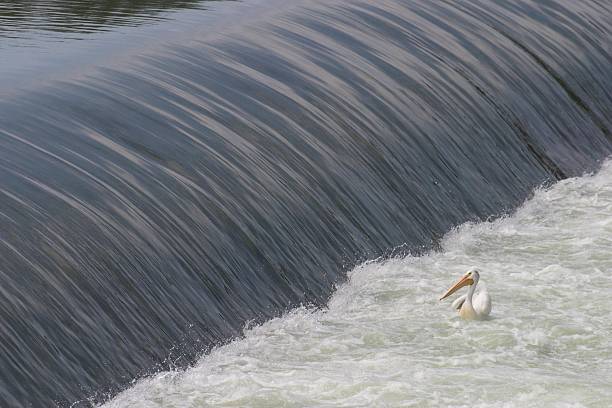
xmin=106 ymin=162 xmax=612 ymax=408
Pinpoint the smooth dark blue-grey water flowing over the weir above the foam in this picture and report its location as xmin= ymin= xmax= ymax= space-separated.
xmin=0 ymin=0 xmax=612 ymax=407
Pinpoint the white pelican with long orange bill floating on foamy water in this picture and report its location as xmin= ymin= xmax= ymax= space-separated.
xmin=440 ymin=268 xmax=491 ymax=320
